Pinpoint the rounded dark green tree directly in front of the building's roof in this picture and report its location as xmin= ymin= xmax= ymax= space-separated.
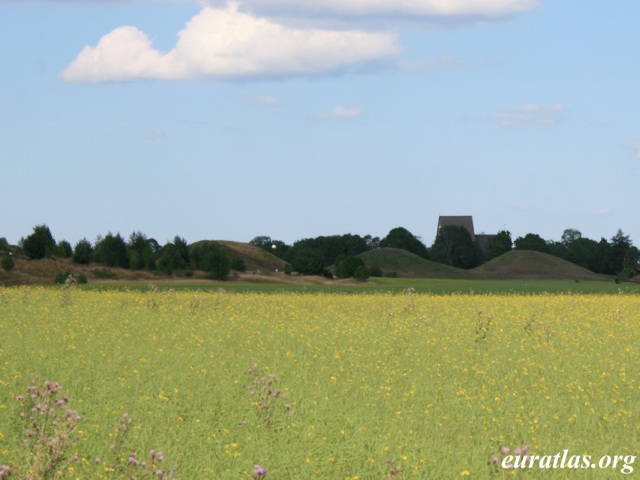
xmin=431 ymin=225 xmax=482 ymax=269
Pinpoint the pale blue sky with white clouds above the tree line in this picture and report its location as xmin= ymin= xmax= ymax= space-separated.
xmin=0 ymin=0 xmax=640 ymax=245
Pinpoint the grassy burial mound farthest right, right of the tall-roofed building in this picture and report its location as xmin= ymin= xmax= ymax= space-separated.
xmin=472 ymin=250 xmax=610 ymax=281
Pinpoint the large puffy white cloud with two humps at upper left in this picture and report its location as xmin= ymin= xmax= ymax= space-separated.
xmin=60 ymin=4 xmax=400 ymax=83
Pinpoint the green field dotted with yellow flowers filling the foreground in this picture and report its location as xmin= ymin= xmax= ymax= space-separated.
xmin=0 ymin=287 xmax=640 ymax=480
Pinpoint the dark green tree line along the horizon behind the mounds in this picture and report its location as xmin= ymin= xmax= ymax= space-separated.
xmin=0 ymin=225 xmax=640 ymax=280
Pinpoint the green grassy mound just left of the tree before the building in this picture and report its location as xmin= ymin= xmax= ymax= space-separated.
xmin=360 ymin=248 xmax=471 ymax=278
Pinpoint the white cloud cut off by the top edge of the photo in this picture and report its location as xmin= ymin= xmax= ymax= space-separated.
xmin=209 ymin=0 xmax=539 ymax=17
